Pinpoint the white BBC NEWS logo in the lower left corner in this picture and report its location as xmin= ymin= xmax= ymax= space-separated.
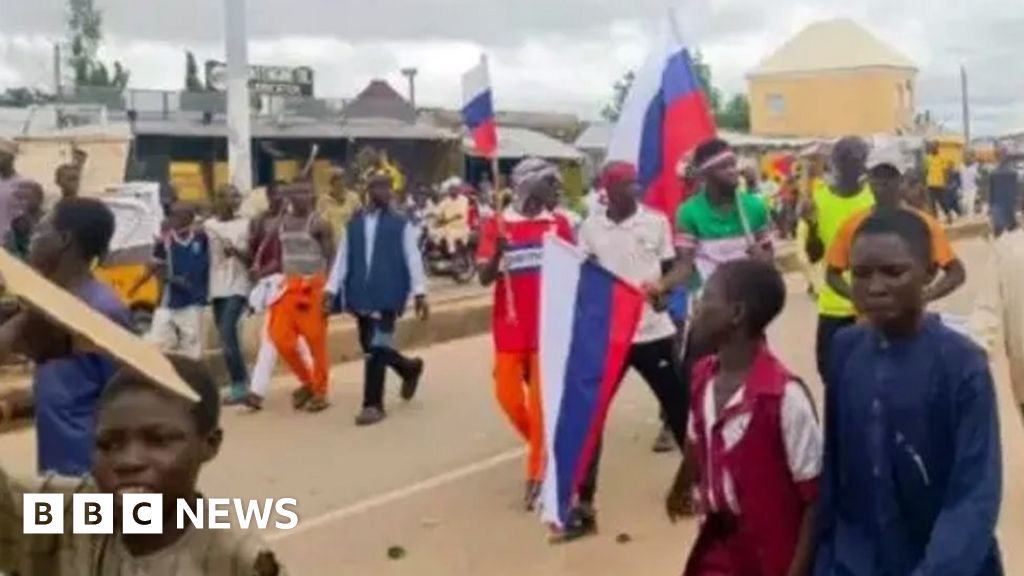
xmin=22 ymin=494 xmax=299 ymax=534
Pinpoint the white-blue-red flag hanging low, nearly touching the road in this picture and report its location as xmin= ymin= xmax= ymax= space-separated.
xmin=540 ymin=236 xmax=644 ymax=528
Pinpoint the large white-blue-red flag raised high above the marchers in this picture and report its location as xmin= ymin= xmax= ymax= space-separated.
xmin=607 ymin=12 xmax=716 ymax=217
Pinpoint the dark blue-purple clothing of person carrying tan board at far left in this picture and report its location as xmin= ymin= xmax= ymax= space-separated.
xmin=32 ymin=280 xmax=131 ymax=476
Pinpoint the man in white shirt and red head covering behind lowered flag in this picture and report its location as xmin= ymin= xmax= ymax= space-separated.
xmin=564 ymin=162 xmax=689 ymax=539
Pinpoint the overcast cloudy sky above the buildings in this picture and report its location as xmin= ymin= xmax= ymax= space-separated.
xmin=0 ymin=0 xmax=1024 ymax=134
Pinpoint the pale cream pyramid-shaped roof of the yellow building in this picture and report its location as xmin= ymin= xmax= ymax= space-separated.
xmin=749 ymin=18 xmax=918 ymax=77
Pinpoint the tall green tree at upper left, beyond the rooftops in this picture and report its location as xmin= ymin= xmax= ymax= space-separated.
xmin=68 ymin=0 xmax=130 ymax=90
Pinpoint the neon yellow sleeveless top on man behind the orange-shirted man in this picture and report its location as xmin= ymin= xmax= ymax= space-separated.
xmin=812 ymin=182 xmax=874 ymax=318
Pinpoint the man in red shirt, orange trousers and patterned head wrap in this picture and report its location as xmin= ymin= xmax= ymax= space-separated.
xmin=477 ymin=158 xmax=572 ymax=509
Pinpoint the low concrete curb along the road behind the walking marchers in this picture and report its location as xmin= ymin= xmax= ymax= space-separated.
xmin=0 ymin=219 xmax=990 ymax=433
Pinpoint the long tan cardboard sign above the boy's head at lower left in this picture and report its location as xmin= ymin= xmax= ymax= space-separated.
xmin=0 ymin=250 xmax=199 ymax=402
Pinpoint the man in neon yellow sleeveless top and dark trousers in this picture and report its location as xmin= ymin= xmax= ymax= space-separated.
xmin=802 ymin=136 xmax=874 ymax=380
